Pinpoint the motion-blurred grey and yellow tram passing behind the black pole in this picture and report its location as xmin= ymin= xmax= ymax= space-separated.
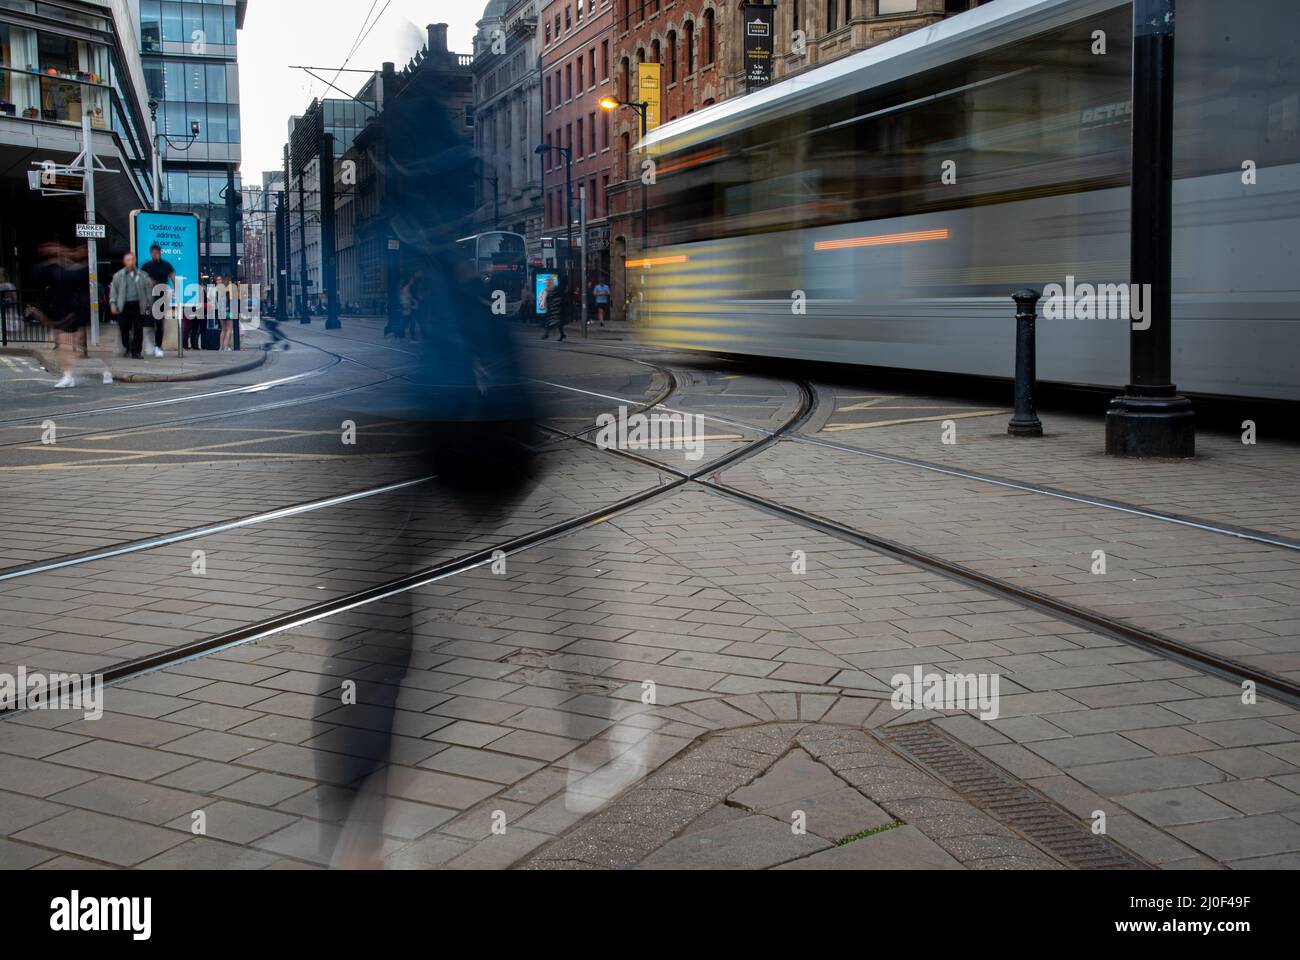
xmin=637 ymin=0 xmax=1300 ymax=401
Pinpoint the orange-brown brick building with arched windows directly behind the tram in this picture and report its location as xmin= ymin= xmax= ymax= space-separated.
xmin=608 ymin=0 xmax=985 ymax=312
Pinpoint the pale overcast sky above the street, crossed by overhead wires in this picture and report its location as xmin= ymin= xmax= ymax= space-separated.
xmin=239 ymin=0 xmax=486 ymax=185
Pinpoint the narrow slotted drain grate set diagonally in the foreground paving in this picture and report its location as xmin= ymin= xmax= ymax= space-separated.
xmin=875 ymin=723 xmax=1151 ymax=870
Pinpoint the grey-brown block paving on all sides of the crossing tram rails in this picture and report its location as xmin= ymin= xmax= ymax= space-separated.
xmin=0 ymin=328 xmax=1300 ymax=869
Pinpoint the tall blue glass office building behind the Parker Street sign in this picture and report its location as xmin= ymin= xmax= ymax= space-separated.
xmin=133 ymin=0 xmax=248 ymax=276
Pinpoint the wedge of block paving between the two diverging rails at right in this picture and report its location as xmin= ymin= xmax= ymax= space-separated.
xmin=723 ymin=444 xmax=1300 ymax=689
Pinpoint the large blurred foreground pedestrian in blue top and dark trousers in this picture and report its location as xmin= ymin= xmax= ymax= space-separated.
xmin=313 ymin=73 xmax=536 ymax=868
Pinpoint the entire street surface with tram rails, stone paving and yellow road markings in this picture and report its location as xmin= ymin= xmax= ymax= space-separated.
xmin=0 ymin=320 xmax=1300 ymax=870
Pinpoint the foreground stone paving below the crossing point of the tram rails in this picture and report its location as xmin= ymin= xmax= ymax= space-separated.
xmin=0 ymin=343 xmax=1300 ymax=869
